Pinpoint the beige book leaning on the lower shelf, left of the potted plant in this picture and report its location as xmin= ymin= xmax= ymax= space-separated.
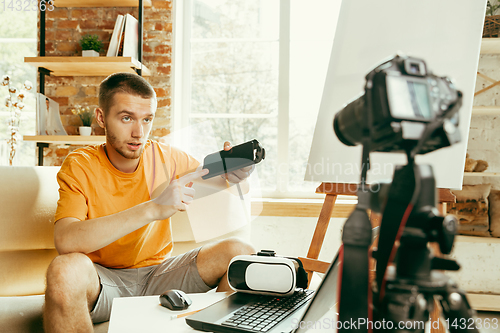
xmin=36 ymin=93 xmax=67 ymax=135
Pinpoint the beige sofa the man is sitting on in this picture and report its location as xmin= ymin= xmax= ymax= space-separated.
xmin=0 ymin=166 xmax=108 ymax=333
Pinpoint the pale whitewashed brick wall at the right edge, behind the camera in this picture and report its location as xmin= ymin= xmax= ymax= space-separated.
xmin=464 ymin=55 xmax=500 ymax=190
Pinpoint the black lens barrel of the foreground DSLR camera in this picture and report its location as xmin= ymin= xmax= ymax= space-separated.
xmin=333 ymin=95 xmax=365 ymax=146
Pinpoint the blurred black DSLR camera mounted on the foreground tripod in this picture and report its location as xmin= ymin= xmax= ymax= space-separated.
xmin=333 ymin=56 xmax=462 ymax=154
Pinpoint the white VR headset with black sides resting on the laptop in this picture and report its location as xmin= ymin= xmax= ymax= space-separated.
xmin=227 ymin=250 xmax=308 ymax=296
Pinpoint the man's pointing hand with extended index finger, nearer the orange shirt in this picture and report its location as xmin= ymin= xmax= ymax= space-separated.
xmin=152 ymin=169 xmax=209 ymax=220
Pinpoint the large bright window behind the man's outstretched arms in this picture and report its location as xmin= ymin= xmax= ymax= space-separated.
xmin=174 ymin=0 xmax=340 ymax=198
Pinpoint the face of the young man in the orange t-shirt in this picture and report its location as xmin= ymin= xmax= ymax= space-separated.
xmin=104 ymin=93 xmax=156 ymax=159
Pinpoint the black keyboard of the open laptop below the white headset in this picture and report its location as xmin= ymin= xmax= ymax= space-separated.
xmin=222 ymin=289 xmax=314 ymax=332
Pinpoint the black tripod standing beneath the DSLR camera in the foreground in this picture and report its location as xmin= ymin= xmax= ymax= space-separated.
xmin=373 ymin=154 xmax=479 ymax=332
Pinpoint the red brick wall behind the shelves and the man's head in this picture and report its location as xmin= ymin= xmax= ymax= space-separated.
xmin=37 ymin=0 xmax=172 ymax=165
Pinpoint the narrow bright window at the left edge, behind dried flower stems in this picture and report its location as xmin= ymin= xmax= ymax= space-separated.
xmin=0 ymin=9 xmax=37 ymax=165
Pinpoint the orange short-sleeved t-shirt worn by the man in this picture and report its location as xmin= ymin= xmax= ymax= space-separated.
xmin=55 ymin=140 xmax=199 ymax=268
